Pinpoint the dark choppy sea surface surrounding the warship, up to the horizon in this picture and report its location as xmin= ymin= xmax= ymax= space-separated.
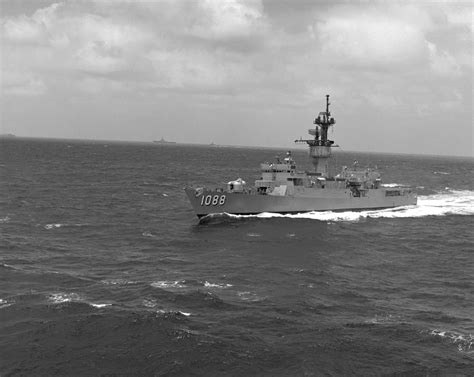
xmin=0 ymin=138 xmax=474 ymax=377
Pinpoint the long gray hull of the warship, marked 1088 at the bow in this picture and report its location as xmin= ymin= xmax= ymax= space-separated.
xmin=185 ymin=188 xmax=417 ymax=217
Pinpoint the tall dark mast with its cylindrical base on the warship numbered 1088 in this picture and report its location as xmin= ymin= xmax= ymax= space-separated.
xmin=295 ymin=94 xmax=336 ymax=177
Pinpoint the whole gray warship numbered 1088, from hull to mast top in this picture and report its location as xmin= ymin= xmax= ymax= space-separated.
xmin=185 ymin=95 xmax=417 ymax=217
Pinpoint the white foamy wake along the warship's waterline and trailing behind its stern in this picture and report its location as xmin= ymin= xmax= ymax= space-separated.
xmin=229 ymin=189 xmax=474 ymax=222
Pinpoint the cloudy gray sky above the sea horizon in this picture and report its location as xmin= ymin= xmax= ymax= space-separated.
xmin=0 ymin=0 xmax=474 ymax=156
